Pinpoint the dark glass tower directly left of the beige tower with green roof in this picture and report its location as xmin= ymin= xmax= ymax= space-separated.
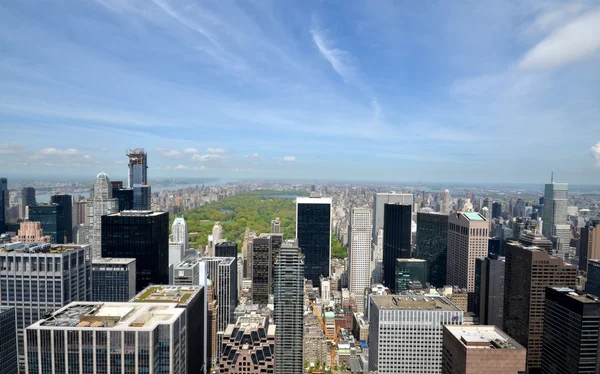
xmin=414 ymin=213 xmax=448 ymax=287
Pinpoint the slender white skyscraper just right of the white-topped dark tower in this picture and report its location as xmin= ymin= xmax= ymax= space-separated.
xmin=348 ymin=208 xmax=371 ymax=313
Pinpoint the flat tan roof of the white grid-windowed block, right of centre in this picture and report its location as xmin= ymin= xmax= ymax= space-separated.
xmin=371 ymin=295 xmax=461 ymax=312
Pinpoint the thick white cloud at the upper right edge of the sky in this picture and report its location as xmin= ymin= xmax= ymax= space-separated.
xmin=519 ymin=10 xmax=600 ymax=69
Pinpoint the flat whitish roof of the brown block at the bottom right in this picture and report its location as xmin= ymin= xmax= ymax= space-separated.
xmin=445 ymin=325 xmax=525 ymax=349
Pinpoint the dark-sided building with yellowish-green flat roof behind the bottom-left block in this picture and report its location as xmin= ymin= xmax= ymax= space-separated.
xmin=131 ymin=285 xmax=210 ymax=374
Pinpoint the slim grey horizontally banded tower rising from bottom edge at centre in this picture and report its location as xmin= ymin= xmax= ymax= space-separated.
xmin=274 ymin=246 xmax=304 ymax=374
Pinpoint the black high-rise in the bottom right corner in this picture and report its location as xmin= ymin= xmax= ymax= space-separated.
xmin=541 ymin=288 xmax=600 ymax=374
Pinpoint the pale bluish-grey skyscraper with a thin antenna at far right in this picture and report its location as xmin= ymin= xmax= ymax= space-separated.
xmin=542 ymin=181 xmax=571 ymax=252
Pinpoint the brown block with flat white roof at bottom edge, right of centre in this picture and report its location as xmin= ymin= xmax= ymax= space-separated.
xmin=442 ymin=325 xmax=527 ymax=374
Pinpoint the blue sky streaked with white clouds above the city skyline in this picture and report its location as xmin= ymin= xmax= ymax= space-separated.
xmin=0 ymin=0 xmax=600 ymax=184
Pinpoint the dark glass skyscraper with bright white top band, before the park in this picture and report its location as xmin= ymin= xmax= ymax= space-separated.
xmin=296 ymin=197 xmax=331 ymax=287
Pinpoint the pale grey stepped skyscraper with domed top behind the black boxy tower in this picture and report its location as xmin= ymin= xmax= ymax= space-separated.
xmin=86 ymin=173 xmax=119 ymax=258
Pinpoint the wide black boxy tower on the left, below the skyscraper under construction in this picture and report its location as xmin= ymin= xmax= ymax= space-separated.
xmin=102 ymin=211 xmax=169 ymax=291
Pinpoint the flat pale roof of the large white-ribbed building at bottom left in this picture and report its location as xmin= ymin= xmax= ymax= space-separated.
xmin=28 ymin=301 xmax=185 ymax=330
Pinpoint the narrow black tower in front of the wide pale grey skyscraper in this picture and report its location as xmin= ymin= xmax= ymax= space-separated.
xmin=383 ymin=204 xmax=412 ymax=293
